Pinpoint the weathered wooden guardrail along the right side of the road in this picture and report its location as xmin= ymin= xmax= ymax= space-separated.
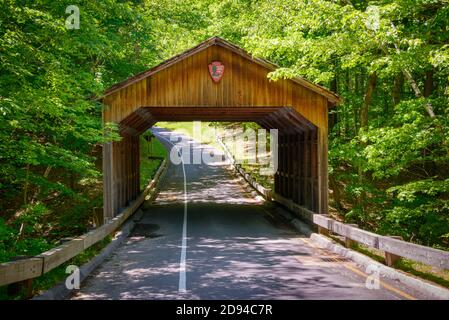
xmin=218 ymin=139 xmax=449 ymax=269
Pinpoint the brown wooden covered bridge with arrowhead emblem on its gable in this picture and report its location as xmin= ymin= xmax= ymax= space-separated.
xmin=102 ymin=37 xmax=339 ymax=219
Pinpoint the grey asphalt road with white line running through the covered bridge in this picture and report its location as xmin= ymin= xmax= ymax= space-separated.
xmin=72 ymin=130 xmax=426 ymax=299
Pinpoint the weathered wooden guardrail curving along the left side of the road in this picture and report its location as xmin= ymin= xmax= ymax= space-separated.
xmin=0 ymin=160 xmax=167 ymax=287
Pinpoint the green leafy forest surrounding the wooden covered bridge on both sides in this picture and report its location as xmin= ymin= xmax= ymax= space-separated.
xmin=0 ymin=0 xmax=449 ymax=268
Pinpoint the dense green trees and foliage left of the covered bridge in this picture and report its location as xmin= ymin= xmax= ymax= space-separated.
xmin=0 ymin=0 xmax=172 ymax=260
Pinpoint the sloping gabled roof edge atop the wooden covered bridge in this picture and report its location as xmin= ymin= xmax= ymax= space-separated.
xmin=103 ymin=37 xmax=341 ymax=104
